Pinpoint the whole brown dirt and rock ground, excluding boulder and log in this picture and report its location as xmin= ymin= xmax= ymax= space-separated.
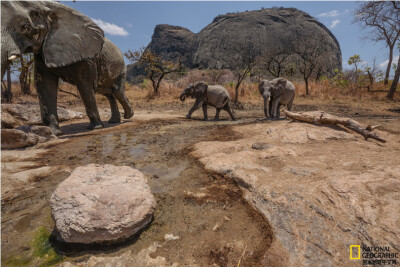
xmin=1 ymin=93 xmax=400 ymax=266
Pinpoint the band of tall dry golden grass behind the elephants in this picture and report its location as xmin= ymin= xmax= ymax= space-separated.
xmin=2 ymin=70 xmax=400 ymax=111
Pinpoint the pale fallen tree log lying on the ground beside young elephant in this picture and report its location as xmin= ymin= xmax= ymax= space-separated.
xmin=285 ymin=110 xmax=386 ymax=143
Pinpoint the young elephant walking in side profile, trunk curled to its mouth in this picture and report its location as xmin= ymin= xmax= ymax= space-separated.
xmin=179 ymin=82 xmax=236 ymax=120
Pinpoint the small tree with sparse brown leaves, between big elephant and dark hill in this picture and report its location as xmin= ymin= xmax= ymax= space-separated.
xmin=124 ymin=48 xmax=183 ymax=95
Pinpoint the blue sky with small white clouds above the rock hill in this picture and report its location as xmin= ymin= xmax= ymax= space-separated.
xmin=62 ymin=0 xmax=398 ymax=73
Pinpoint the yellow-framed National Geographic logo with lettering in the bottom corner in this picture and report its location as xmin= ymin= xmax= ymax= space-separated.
xmin=350 ymin=245 xmax=399 ymax=266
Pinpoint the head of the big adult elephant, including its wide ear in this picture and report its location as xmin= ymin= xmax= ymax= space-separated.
xmin=1 ymin=1 xmax=104 ymax=75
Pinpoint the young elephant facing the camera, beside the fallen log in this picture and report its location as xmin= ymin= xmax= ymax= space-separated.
xmin=258 ymin=78 xmax=296 ymax=119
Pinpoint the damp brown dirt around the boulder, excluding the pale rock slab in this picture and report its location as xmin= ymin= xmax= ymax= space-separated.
xmin=2 ymin=99 xmax=400 ymax=266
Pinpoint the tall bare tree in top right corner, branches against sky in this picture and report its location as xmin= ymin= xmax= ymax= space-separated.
xmin=354 ymin=1 xmax=400 ymax=85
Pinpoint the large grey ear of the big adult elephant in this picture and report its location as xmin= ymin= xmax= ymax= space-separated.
xmin=39 ymin=2 xmax=104 ymax=68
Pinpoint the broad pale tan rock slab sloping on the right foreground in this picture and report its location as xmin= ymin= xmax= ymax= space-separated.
xmin=192 ymin=121 xmax=400 ymax=266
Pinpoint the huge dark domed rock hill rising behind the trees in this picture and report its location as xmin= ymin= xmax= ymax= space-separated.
xmin=128 ymin=8 xmax=342 ymax=81
